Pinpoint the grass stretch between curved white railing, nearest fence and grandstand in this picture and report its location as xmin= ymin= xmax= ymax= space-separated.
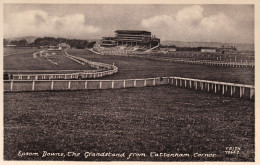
xmin=68 ymin=49 xmax=254 ymax=84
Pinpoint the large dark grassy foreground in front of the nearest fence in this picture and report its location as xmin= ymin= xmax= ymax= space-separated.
xmin=4 ymin=86 xmax=254 ymax=161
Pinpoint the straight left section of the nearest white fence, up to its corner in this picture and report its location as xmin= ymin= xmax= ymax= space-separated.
xmin=4 ymin=77 xmax=168 ymax=92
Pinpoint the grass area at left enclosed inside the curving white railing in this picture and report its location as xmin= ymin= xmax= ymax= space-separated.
xmin=4 ymin=49 xmax=93 ymax=70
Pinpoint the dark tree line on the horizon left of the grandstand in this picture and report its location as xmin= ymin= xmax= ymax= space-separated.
xmin=3 ymin=37 xmax=96 ymax=49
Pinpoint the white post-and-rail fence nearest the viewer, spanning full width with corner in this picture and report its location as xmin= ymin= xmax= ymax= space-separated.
xmin=4 ymin=77 xmax=255 ymax=99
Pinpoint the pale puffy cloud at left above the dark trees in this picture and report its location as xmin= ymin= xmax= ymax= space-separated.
xmin=4 ymin=10 xmax=101 ymax=38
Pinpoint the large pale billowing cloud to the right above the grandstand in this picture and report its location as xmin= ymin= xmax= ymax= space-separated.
xmin=141 ymin=5 xmax=237 ymax=42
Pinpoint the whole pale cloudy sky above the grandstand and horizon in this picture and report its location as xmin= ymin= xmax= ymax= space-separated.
xmin=4 ymin=4 xmax=254 ymax=43
